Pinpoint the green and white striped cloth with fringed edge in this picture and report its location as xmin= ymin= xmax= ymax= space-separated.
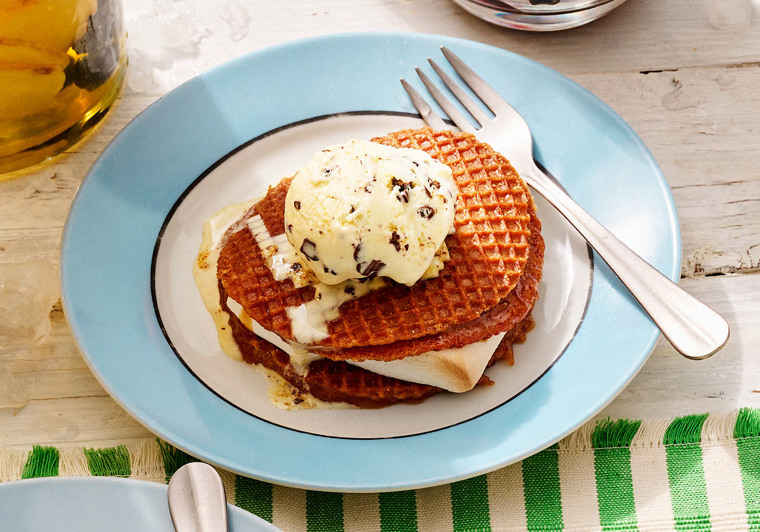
xmin=0 ymin=408 xmax=760 ymax=532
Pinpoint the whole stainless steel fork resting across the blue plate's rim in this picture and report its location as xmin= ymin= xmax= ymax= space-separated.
xmin=401 ymin=47 xmax=730 ymax=359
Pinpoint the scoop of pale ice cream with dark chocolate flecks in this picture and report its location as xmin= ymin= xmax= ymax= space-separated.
xmin=285 ymin=140 xmax=457 ymax=285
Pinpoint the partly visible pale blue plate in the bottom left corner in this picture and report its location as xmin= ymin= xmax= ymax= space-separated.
xmin=0 ymin=477 xmax=279 ymax=532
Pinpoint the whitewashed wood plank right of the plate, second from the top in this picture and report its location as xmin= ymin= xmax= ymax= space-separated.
xmin=576 ymin=66 xmax=760 ymax=276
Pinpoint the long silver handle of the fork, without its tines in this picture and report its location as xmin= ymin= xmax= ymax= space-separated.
xmin=521 ymin=165 xmax=730 ymax=360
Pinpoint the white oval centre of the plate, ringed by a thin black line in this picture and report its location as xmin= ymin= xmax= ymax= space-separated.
xmin=153 ymin=113 xmax=593 ymax=438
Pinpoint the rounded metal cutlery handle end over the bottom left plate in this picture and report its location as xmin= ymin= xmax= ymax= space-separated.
xmin=169 ymin=462 xmax=227 ymax=532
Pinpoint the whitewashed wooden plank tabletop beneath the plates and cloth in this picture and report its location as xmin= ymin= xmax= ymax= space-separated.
xmin=0 ymin=0 xmax=760 ymax=448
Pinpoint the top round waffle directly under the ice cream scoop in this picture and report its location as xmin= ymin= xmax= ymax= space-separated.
xmin=217 ymin=128 xmax=543 ymax=359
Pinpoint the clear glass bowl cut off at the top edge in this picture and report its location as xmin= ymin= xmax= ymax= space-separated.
xmin=453 ymin=0 xmax=625 ymax=31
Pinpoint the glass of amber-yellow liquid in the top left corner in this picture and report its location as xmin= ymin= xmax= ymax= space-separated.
xmin=0 ymin=0 xmax=126 ymax=174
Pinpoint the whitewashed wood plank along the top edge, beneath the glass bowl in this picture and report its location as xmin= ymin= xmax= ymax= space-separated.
xmin=117 ymin=0 xmax=760 ymax=91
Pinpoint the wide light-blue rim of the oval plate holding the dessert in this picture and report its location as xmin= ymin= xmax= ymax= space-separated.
xmin=61 ymin=33 xmax=680 ymax=491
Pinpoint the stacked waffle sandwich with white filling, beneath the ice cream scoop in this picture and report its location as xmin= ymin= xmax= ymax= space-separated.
xmin=205 ymin=128 xmax=544 ymax=407
